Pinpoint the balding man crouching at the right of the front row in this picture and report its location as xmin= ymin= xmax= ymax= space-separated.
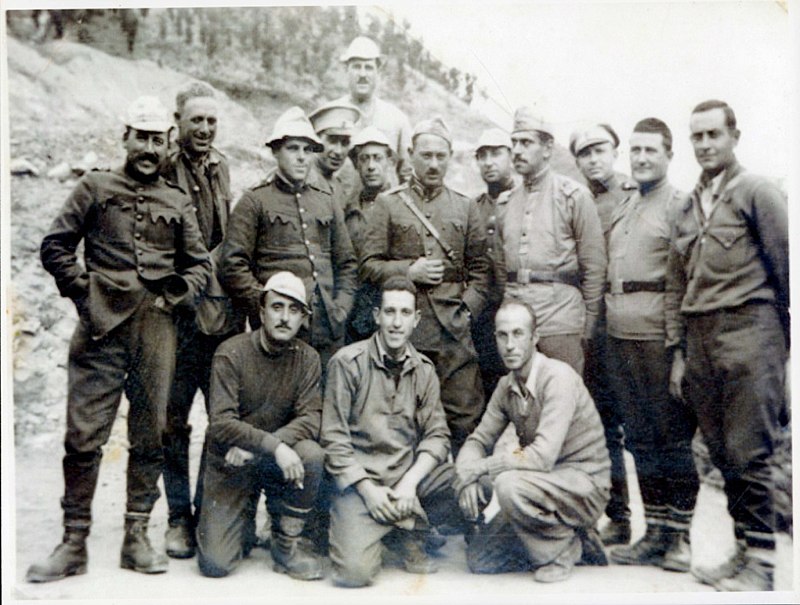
xmin=456 ymin=301 xmax=611 ymax=582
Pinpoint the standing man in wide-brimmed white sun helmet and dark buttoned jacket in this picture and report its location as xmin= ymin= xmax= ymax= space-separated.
xmin=220 ymin=107 xmax=357 ymax=380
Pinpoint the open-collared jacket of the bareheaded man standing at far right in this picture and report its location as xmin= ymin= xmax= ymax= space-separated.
xmin=667 ymin=164 xmax=789 ymax=343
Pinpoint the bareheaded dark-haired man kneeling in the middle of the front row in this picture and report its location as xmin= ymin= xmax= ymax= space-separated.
xmin=321 ymin=276 xmax=461 ymax=587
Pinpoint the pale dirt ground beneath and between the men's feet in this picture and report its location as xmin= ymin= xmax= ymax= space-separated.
xmin=11 ymin=400 xmax=796 ymax=602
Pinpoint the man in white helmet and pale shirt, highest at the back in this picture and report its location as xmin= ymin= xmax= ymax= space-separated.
xmin=336 ymin=36 xmax=412 ymax=183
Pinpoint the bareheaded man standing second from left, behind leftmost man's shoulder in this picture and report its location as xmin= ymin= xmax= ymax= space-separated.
xmin=159 ymin=83 xmax=244 ymax=558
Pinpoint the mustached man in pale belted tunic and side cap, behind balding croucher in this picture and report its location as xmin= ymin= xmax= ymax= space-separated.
xmin=498 ymin=107 xmax=607 ymax=375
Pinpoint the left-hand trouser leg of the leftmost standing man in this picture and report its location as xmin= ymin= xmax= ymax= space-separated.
xmin=61 ymin=322 xmax=128 ymax=528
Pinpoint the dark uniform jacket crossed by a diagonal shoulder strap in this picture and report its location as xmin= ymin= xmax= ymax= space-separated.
xmin=360 ymin=178 xmax=489 ymax=350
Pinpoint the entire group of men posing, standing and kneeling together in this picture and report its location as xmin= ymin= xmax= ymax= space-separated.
xmin=27 ymin=37 xmax=789 ymax=590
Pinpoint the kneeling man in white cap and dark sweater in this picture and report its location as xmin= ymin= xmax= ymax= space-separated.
xmin=197 ymin=271 xmax=324 ymax=580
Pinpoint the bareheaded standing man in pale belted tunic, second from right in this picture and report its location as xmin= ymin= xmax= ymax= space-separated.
xmin=604 ymin=118 xmax=699 ymax=571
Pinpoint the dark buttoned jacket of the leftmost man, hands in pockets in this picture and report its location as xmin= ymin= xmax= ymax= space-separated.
xmin=41 ymin=168 xmax=211 ymax=338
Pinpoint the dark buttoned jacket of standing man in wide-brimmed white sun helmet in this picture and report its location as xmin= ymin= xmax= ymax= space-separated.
xmin=220 ymin=173 xmax=357 ymax=338
